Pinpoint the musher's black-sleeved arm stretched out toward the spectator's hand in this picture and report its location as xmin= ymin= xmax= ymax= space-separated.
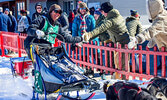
xmin=56 ymin=27 xmax=83 ymax=44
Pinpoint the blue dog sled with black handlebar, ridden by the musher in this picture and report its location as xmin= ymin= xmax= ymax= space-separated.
xmin=30 ymin=32 xmax=100 ymax=100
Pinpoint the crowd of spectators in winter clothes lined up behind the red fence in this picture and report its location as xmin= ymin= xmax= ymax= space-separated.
xmin=0 ymin=0 xmax=167 ymax=79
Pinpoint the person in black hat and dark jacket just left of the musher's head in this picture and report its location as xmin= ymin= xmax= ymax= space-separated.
xmin=32 ymin=2 xmax=42 ymax=21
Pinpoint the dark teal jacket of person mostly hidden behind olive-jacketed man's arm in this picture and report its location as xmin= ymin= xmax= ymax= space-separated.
xmin=93 ymin=14 xmax=110 ymax=42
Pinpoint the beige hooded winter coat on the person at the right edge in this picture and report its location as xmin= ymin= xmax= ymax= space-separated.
xmin=137 ymin=0 xmax=167 ymax=50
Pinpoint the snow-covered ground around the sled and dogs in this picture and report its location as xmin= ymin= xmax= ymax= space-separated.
xmin=0 ymin=57 xmax=149 ymax=100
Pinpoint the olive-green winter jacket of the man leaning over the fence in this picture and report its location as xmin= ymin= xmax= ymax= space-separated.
xmin=90 ymin=9 xmax=129 ymax=44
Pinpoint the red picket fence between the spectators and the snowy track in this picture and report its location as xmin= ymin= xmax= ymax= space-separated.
xmin=0 ymin=32 xmax=167 ymax=80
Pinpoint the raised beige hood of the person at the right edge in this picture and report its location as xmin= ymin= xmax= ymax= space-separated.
xmin=146 ymin=0 xmax=165 ymax=19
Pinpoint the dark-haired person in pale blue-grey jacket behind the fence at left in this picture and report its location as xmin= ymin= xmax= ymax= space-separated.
xmin=18 ymin=10 xmax=29 ymax=33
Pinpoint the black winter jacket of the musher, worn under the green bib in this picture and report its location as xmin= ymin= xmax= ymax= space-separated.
xmin=24 ymin=16 xmax=82 ymax=48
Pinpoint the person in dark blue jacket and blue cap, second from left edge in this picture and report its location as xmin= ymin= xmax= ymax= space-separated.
xmin=4 ymin=8 xmax=17 ymax=32
